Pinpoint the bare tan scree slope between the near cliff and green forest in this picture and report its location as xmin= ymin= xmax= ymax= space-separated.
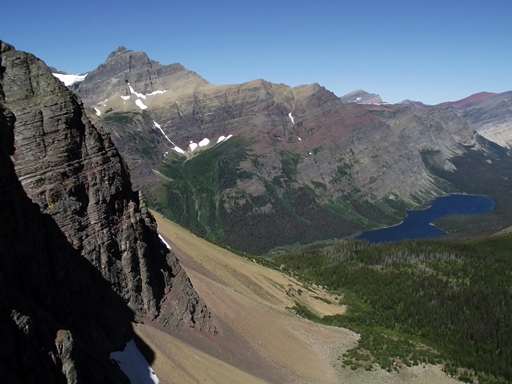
xmin=135 ymin=212 xmax=457 ymax=384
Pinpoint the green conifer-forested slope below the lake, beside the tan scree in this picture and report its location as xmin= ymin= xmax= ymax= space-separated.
xmin=275 ymin=234 xmax=512 ymax=383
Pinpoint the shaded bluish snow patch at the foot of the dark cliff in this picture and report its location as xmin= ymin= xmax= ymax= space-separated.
xmin=110 ymin=339 xmax=160 ymax=384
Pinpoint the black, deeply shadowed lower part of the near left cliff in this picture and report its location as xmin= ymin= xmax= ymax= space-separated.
xmin=0 ymin=43 xmax=134 ymax=383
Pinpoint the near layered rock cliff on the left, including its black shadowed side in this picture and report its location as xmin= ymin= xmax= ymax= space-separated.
xmin=0 ymin=42 xmax=213 ymax=382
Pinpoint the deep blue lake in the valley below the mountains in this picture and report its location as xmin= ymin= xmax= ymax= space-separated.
xmin=356 ymin=194 xmax=494 ymax=243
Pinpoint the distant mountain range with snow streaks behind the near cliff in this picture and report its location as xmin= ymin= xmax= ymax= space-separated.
xmin=56 ymin=47 xmax=512 ymax=254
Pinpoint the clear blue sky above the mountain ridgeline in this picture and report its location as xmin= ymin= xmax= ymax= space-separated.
xmin=0 ymin=0 xmax=512 ymax=104
